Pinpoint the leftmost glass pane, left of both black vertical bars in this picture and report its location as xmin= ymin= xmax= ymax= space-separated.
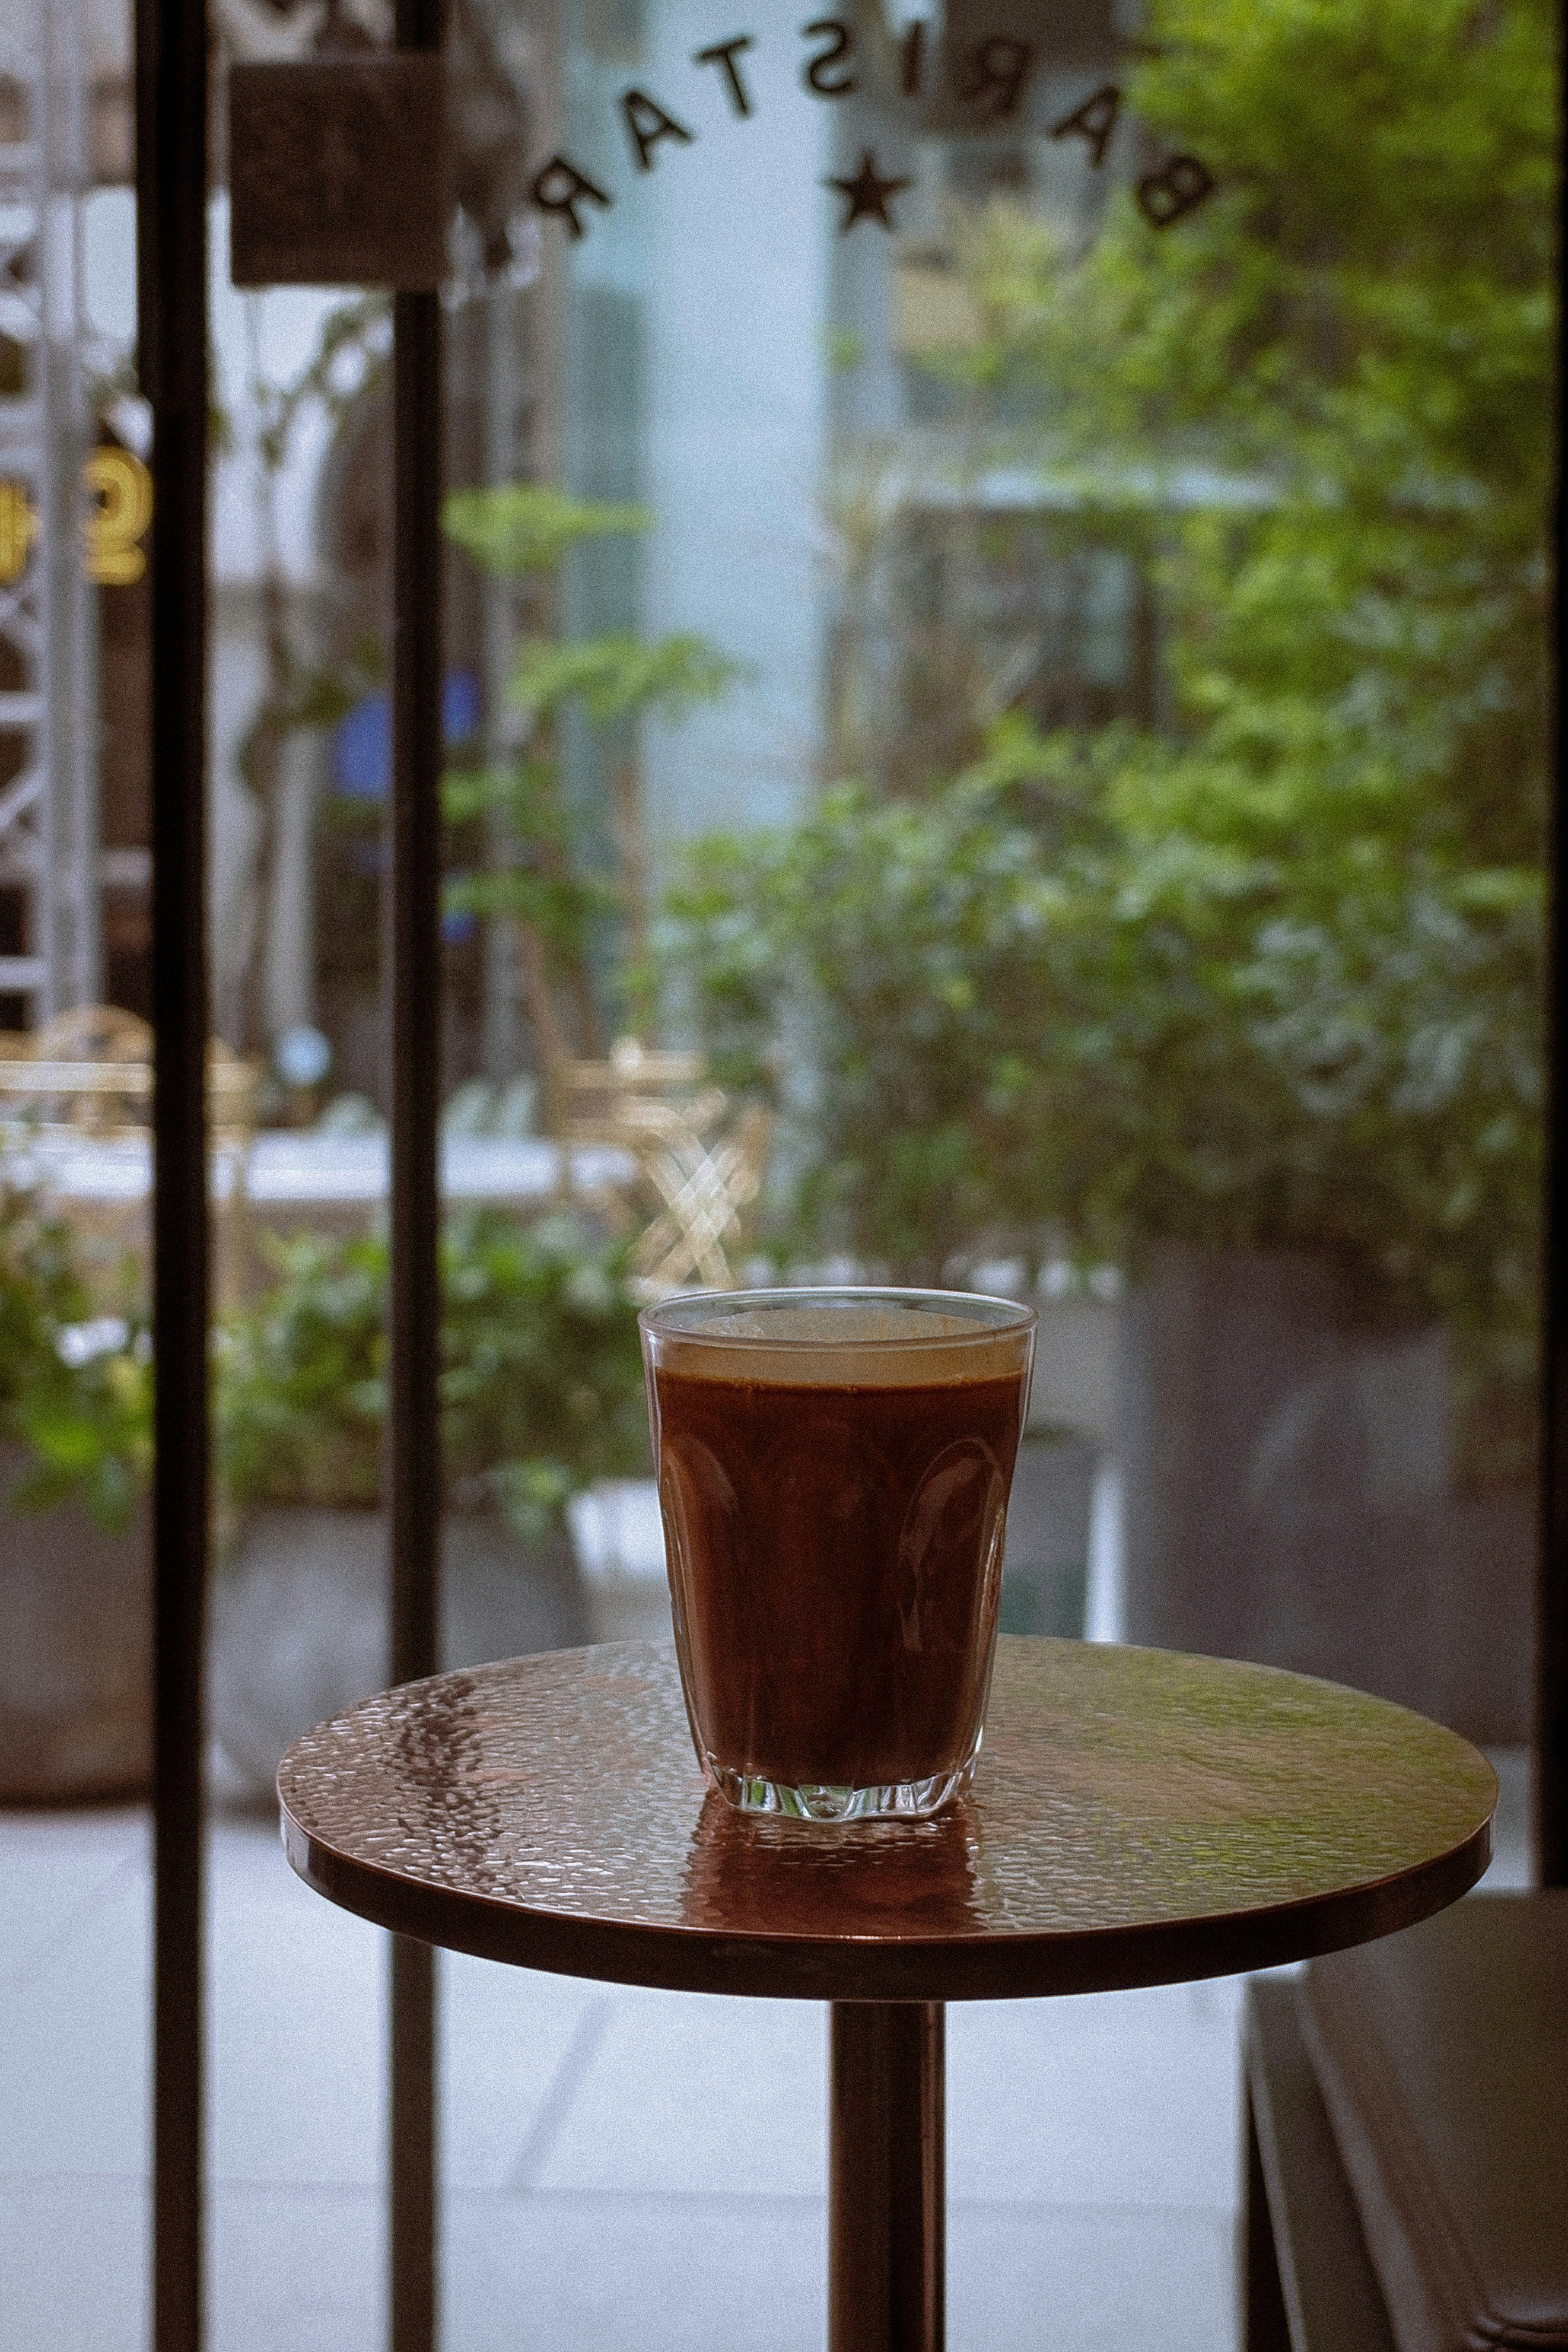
xmin=0 ymin=0 xmax=153 ymax=2342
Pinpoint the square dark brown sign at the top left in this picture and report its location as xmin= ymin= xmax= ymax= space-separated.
xmin=228 ymin=52 xmax=449 ymax=294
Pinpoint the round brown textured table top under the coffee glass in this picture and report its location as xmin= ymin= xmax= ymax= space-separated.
xmin=277 ymin=1637 xmax=1498 ymax=2002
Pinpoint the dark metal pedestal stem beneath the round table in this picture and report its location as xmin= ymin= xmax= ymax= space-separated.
xmin=827 ymin=2002 xmax=948 ymax=2352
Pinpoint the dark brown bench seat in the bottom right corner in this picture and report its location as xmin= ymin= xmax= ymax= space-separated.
xmin=1246 ymin=1891 xmax=1568 ymax=2352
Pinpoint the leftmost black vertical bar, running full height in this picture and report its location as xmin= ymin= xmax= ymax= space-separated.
xmin=137 ymin=0 xmax=207 ymax=2352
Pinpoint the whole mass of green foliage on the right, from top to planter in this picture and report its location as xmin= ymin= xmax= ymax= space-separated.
xmin=670 ymin=0 xmax=1556 ymax=1449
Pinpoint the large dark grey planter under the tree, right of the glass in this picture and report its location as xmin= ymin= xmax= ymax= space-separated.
xmin=1119 ymin=1249 xmax=1535 ymax=1745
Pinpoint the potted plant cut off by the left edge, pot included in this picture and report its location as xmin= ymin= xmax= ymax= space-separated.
xmin=0 ymin=1188 xmax=153 ymax=1802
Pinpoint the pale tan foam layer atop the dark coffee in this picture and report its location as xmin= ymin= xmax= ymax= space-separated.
xmin=656 ymin=1301 xmax=1030 ymax=1388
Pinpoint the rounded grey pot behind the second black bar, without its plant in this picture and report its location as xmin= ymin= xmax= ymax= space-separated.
xmin=212 ymin=1510 xmax=588 ymax=1795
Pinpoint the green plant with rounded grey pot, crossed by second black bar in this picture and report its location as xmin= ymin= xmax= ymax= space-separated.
xmin=212 ymin=1209 xmax=646 ymax=1785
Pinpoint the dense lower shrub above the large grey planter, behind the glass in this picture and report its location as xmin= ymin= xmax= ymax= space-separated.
xmin=663 ymin=722 xmax=1542 ymax=1378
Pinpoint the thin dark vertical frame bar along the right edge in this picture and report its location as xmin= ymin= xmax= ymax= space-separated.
xmin=1535 ymin=16 xmax=1568 ymax=1886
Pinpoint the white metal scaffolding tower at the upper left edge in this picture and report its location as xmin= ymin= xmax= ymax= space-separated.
xmin=0 ymin=0 xmax=103 ymax=1023
